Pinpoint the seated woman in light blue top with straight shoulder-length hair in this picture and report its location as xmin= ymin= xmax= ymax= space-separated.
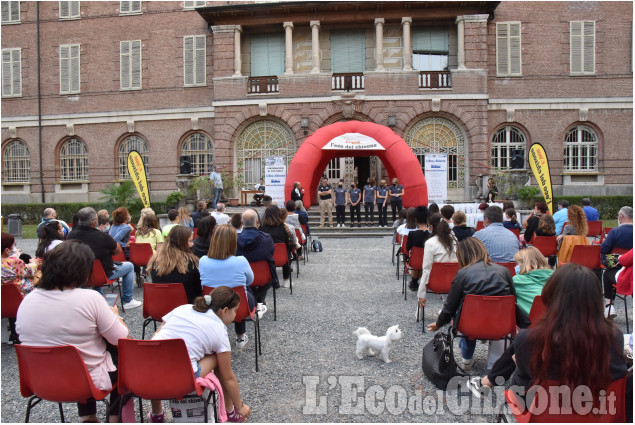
xmin=198 ymin=224 xmax=256 ymax=349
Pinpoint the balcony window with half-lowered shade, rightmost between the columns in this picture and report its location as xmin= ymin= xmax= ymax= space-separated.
xmin=412 ymin=28 xmax=449 ymax=71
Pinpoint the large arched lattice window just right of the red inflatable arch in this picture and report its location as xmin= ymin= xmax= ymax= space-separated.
xmin=406 ymin=117 xmax=465 ymax=189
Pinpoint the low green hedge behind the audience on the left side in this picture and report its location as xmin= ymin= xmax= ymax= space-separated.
xmin=2 ymin=202 xmax=168 ymax=224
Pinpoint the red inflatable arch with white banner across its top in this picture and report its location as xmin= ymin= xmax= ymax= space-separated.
xmin=284 ymin=121 xmax=428 ymax=207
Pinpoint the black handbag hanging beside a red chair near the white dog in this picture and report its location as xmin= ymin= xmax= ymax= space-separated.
xmin=421 ymin=326 xmax=465 ymax=391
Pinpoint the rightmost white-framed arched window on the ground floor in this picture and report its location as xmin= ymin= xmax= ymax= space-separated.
xmin=564 ymin=125 xmax=598 ymax=171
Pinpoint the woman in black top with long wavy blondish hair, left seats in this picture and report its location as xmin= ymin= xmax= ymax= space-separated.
xmin=148 ymin=226 xmax=201 ymax=303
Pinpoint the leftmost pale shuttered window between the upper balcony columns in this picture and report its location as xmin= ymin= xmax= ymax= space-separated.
xmin=251 ymin=33 xmax=284 ymax=77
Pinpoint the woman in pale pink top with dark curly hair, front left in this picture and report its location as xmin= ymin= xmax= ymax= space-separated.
xmin=16 ymin=240 xmax=128 ymax=422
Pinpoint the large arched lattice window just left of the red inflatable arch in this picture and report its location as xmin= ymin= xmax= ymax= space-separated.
xmin=236 ymin=120 xmax=296 ymax=186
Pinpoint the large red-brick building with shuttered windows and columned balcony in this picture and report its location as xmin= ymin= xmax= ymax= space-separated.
xmin=2 ymin=0 xmax=633 ymax=202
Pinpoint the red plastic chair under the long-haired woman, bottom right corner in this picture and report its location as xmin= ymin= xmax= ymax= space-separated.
xmin=498 ymin=376 xmax=627 ymax=423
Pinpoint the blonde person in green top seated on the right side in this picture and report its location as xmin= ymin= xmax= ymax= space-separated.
xmin=512 ymin=246 xmax=553 ymax=314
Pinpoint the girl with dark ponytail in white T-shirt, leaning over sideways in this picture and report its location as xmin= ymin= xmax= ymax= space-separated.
xmin=148 ymin=286 xmax=251 ymax=422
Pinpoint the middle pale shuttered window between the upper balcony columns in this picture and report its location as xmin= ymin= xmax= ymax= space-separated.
xmin=331 ymin=30 xmax=366 ymax=74
